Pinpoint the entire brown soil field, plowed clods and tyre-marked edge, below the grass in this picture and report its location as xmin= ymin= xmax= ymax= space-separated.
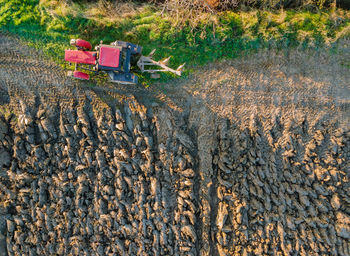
xmin=0 ymin=31 xmax=350 ymax=255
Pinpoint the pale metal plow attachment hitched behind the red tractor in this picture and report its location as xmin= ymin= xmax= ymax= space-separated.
xmin=137 ymin=49 xmax=185 ymax=76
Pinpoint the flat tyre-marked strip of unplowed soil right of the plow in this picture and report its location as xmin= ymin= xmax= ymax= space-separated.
xmin=172 ymin=45 xmax=350 ymax=129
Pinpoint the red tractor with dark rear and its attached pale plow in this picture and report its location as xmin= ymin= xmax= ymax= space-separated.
xmin=64 ymin=39 xmax=184 ymax=84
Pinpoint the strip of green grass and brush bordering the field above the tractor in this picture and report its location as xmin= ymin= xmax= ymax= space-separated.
xmin=0 ymin=0 xmax=350 ymax=82
